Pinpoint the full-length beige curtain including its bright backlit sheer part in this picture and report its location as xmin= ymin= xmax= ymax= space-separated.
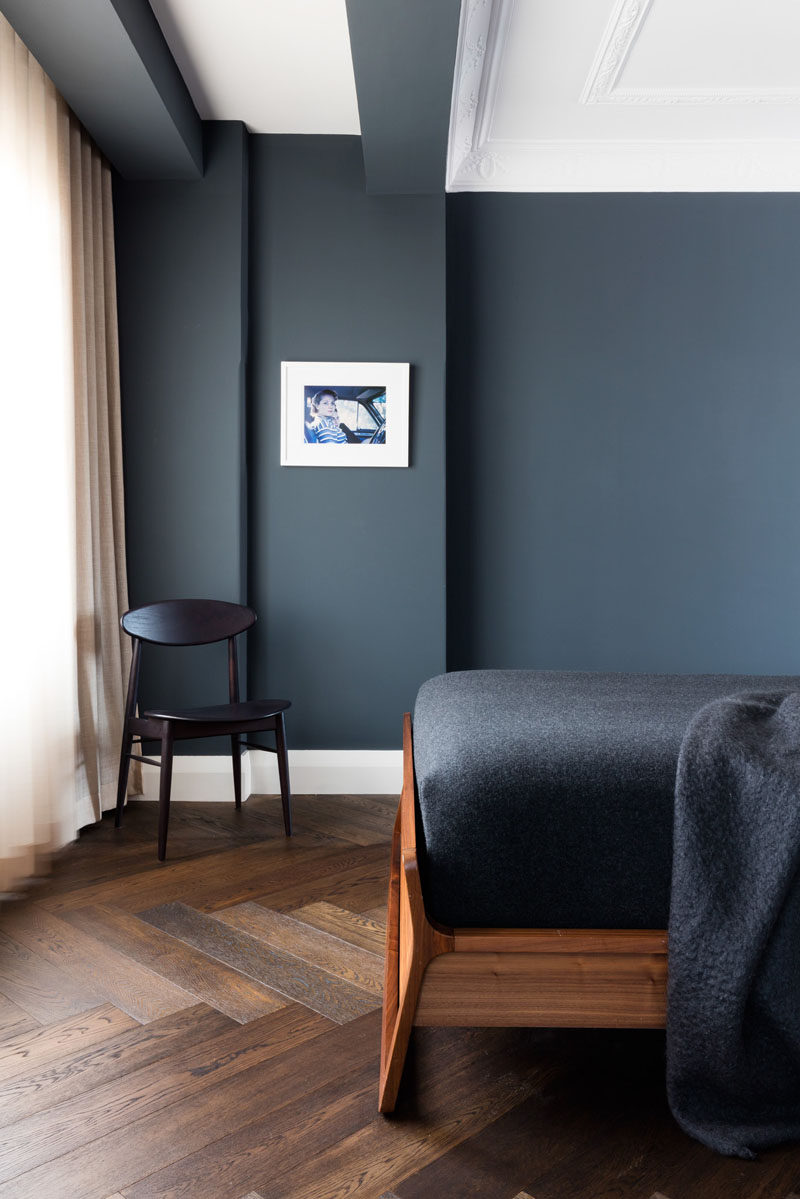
xmin=0 ymin=9 xmax=138 ymax=892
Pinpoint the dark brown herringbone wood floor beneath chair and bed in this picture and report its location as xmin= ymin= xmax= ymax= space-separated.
xmin=0 ymin=796 xmax=800 ymax=1199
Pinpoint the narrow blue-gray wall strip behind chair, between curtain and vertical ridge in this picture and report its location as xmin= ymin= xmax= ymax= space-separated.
xmin=114 ymin=122 xmax=248 ymax=714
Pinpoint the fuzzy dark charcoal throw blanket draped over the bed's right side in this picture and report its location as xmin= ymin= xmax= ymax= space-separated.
xmin=667 ymin=692 xmax=800 ymax=1158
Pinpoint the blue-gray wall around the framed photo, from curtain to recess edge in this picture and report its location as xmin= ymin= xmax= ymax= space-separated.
xmin=115 ymin=133 xmax=446 ymax=752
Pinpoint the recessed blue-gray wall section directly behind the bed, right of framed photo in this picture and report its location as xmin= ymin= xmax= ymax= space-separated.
xmin=447 ymin=194 xmax=800 ymax=673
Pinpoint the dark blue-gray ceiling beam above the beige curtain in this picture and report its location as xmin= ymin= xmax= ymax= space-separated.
xmin=0 ymin=0 xmax=203 ymax=179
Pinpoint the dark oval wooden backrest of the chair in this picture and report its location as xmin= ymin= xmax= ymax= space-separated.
xmin=120 ymin=600 xmax=258 ymax=645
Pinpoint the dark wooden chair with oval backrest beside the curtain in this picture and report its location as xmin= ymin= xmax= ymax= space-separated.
xmin=115 ymin=600 xmax=291 ymax=862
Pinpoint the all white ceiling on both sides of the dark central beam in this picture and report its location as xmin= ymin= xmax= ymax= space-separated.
xmin=150 ymin=0 xmax=800 ymax=192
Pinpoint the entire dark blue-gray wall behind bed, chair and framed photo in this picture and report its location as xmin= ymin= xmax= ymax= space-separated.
xmin=115 ymin=137 xmax=800 ymax=748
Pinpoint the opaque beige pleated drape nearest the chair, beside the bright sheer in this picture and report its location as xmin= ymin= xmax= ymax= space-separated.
xmin=68 ymin=107 xmax=140 ymax=826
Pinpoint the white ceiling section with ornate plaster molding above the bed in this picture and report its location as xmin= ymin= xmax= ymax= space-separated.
xmin=446 ymin=0 xmax=800 ymax=192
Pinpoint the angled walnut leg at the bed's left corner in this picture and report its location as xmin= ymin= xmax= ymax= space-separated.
xmin=378 ymin=715 xmax=455 ymax=1113
